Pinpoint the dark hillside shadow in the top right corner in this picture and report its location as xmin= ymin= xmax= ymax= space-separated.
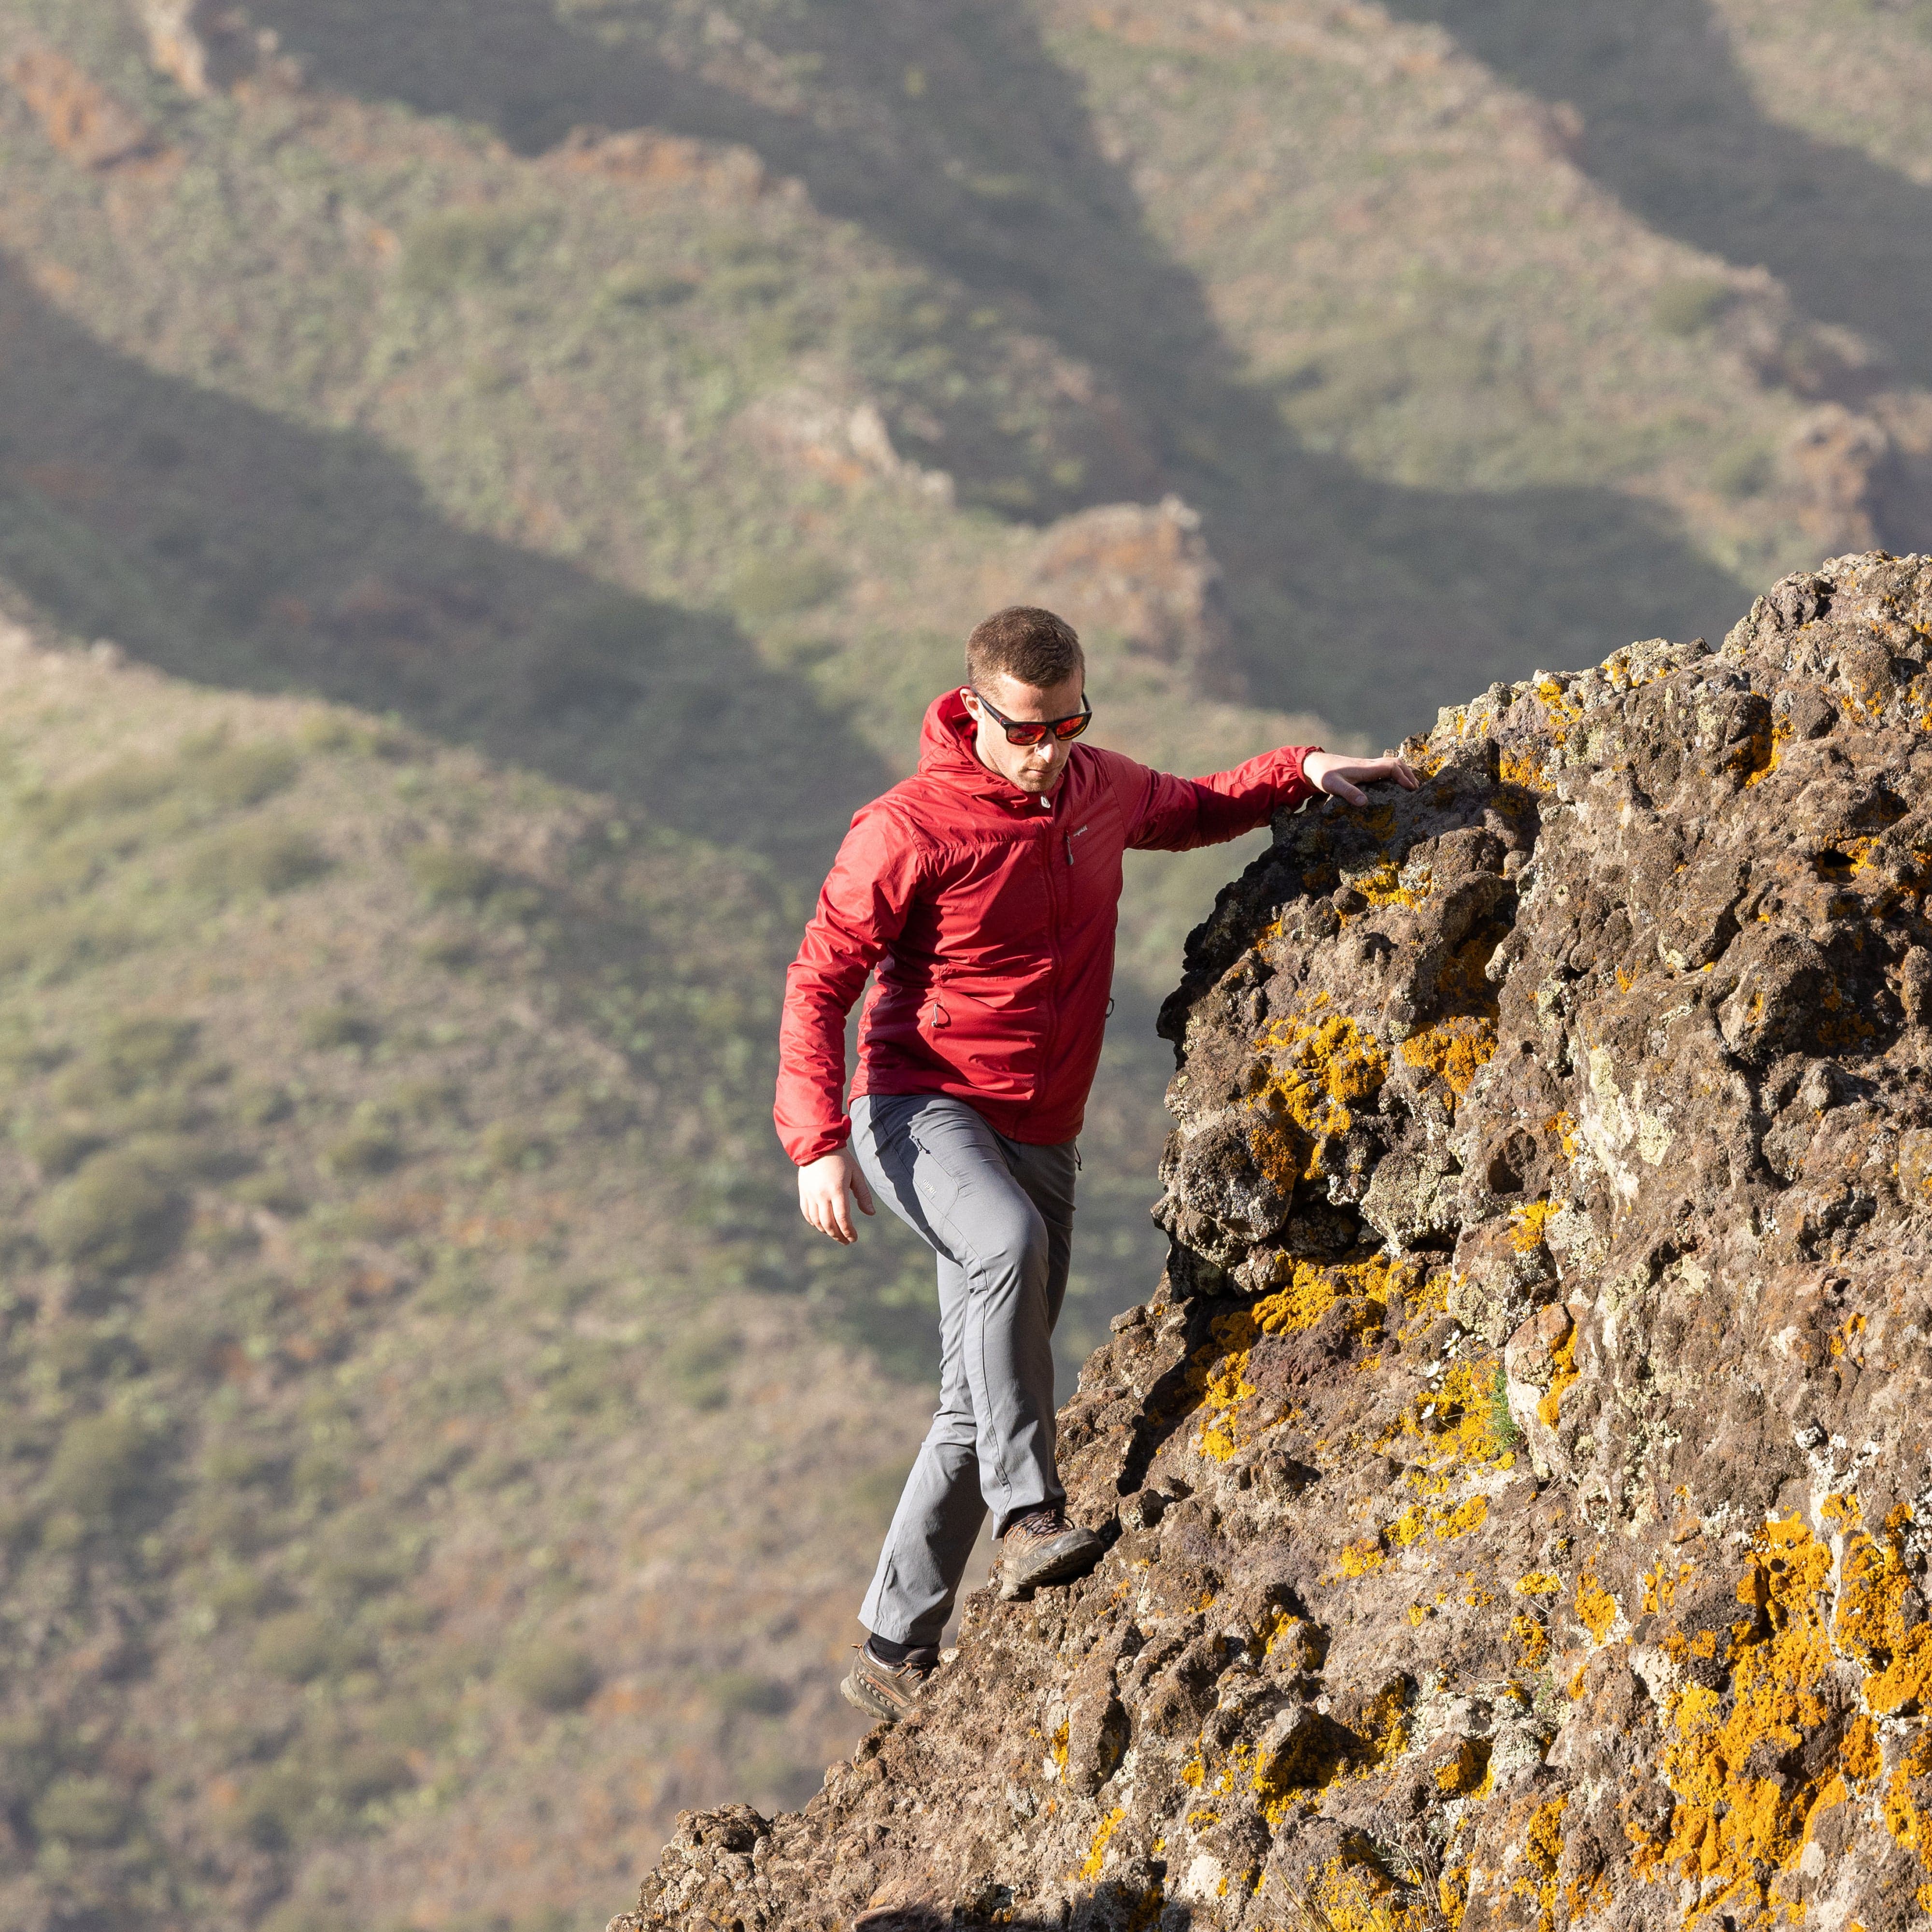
xmin=1389 ymin=0 xmax=1932 ymax=384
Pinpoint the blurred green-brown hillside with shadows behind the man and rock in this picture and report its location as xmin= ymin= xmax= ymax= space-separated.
xmin=0 ymin=0 xmax=1932 ymax=1932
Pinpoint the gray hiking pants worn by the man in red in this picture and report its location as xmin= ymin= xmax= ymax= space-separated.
xmin=852 ymin=1094 xmax=1078 ymax=1644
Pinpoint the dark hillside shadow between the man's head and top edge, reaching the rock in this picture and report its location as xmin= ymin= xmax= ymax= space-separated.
xmin=251 ymin=0 xmax=1741 ymax=738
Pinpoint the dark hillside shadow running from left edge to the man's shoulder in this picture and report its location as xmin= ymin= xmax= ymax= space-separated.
xmin=0 ymin=259 xmax=891 ymax=883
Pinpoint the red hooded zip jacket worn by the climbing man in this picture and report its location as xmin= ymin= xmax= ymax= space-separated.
xmin=773 ymin=690 xmax=1316 ymax=1165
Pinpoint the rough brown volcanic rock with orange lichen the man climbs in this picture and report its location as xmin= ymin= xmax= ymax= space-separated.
xmin=614 ymin=553 xmax=1932 ymax=1932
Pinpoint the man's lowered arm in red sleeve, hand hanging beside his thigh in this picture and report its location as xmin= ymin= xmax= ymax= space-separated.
xmin=773 ymin=811 xmax=918 ymax=1242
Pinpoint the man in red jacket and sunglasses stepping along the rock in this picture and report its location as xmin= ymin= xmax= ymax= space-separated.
xmin=775 ymin=607 xmax=1416 ymax=1721
